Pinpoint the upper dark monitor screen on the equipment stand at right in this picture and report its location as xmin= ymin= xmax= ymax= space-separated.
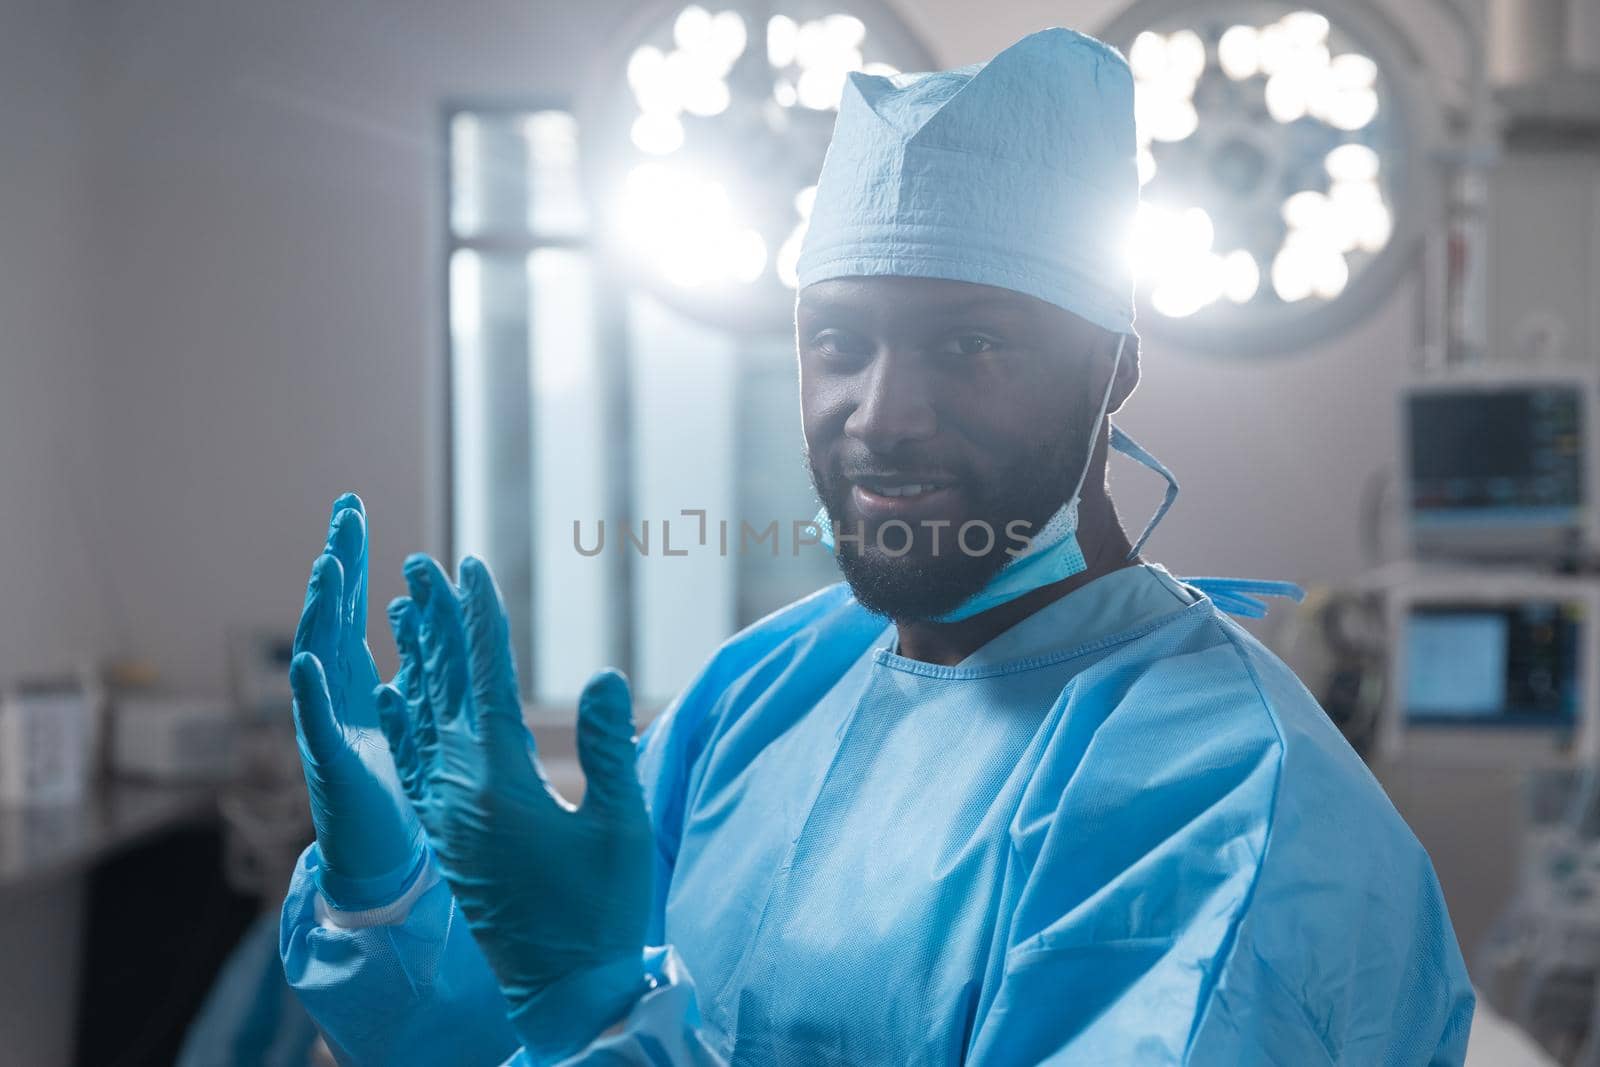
xmin=1408 ymin=384 xmax=1584 ymax=525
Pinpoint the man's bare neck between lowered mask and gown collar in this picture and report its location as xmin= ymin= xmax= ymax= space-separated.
xmin=894 ymin=490 xmax=1138 ymax=667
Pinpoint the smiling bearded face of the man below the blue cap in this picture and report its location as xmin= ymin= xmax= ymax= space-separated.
xmin=795 ymin=277 xmax=1136 ymax=621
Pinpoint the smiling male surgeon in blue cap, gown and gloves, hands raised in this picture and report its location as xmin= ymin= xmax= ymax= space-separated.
xmin=282 ymin=29 xmax=1474 ymax=1067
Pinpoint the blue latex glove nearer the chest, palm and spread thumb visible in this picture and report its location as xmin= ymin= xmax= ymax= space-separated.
xmin=379 ymin=555 xmax=651 ymax=1061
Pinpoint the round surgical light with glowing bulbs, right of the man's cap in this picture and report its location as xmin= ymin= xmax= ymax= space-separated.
xmin=1106 ymin=0 xmax=1413 ymax=358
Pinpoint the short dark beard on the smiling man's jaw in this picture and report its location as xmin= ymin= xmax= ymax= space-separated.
xmin=806 ymin=432 xmax=1085 ymax=622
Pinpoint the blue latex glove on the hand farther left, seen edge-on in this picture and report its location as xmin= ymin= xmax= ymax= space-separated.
xmin=290 ymin=493 xmax=424 ymax=910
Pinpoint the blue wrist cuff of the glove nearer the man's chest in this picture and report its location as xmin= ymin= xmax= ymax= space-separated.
xmin=510 ymin=955 xmax=651 ymax=1064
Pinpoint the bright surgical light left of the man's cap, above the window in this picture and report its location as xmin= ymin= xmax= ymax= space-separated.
xmin=601 ymin=0 xmax=934 ymax=325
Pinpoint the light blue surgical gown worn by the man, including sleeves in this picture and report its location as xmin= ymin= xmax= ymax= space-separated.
xmin=280 ymin=565 xmax=1474 ymax=1067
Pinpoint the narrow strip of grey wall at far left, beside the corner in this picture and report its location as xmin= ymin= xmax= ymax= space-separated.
xmin=0 ymin=0 xmax=101 ymax=680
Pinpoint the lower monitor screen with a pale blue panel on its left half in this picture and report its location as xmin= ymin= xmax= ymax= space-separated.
xmin=1405 ymin=600 xmax=1584 ymax=726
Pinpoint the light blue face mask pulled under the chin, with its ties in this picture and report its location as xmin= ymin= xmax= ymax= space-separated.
xmin=814 ymin=334 xmax=1178 ymax=622
